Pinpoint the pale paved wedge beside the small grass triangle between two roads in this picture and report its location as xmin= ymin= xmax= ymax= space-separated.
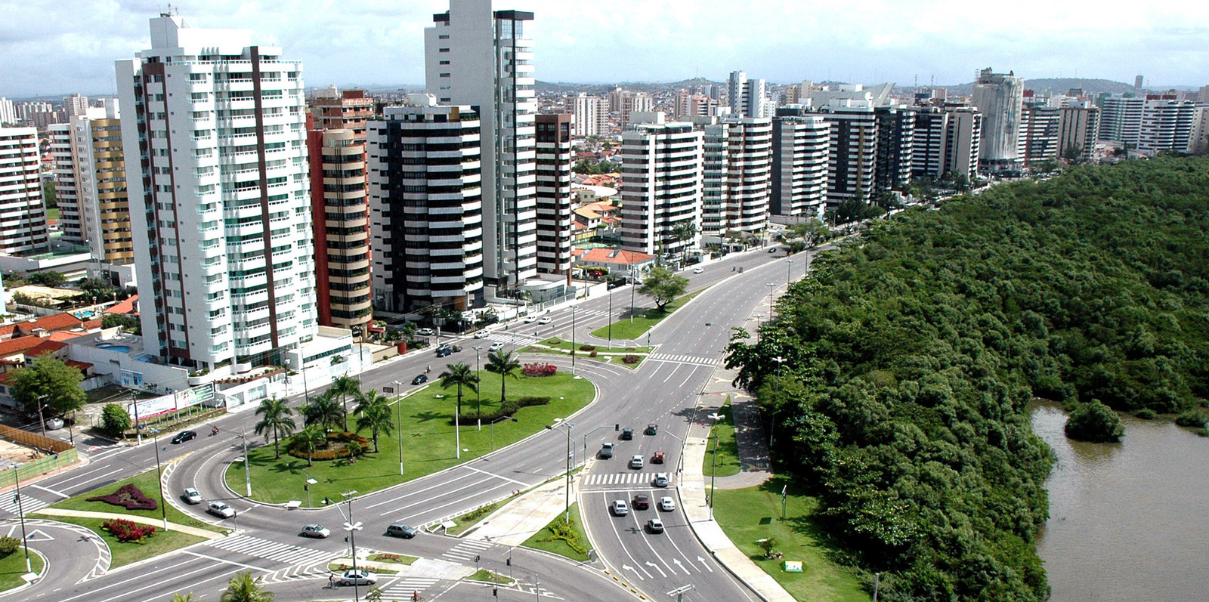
xmin=464 ymin=469 xmax=580 ymax=545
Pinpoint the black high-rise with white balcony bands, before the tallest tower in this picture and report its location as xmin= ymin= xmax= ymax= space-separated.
xmin=366 ymin=99 xmax=486 ymax=313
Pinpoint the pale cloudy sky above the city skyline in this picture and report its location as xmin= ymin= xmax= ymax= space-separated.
xmin=0 ymin=0 xmax=1209 ymax=98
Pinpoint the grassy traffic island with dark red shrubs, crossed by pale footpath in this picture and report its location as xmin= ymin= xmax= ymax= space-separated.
xmin=30 ymin=470 xmax=226 ymax=569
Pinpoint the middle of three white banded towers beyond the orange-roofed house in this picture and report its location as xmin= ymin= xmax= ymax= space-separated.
xmin=700 ymin=116 xmax=773 ymax=243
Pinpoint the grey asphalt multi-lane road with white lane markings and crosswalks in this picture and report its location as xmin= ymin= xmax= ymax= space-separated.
xmin=0 ymin=245 xmax=805 ymax=602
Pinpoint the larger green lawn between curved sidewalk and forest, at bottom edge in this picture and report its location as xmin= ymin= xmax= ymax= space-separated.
xmin=713 ymin=476 xmax=869 ymax=602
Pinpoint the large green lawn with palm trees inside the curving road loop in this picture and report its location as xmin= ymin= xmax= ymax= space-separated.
xmin=226 ymin=372 xmax=595 ymax=507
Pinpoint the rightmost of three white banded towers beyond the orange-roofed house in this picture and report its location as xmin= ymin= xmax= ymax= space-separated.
xmin=769 ymin=105 xmax=831 ymax=218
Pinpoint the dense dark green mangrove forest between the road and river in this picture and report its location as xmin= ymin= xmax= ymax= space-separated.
xmin=728 ymin=158 xmax=1209 ymax=601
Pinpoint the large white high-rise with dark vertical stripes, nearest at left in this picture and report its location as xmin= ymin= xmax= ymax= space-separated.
xmin=116 ymin=15 xmax=318 ymax=374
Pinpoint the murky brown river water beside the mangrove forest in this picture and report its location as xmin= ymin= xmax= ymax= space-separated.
xmin=1031 ymin=404 xmax=1209 ymax=602
